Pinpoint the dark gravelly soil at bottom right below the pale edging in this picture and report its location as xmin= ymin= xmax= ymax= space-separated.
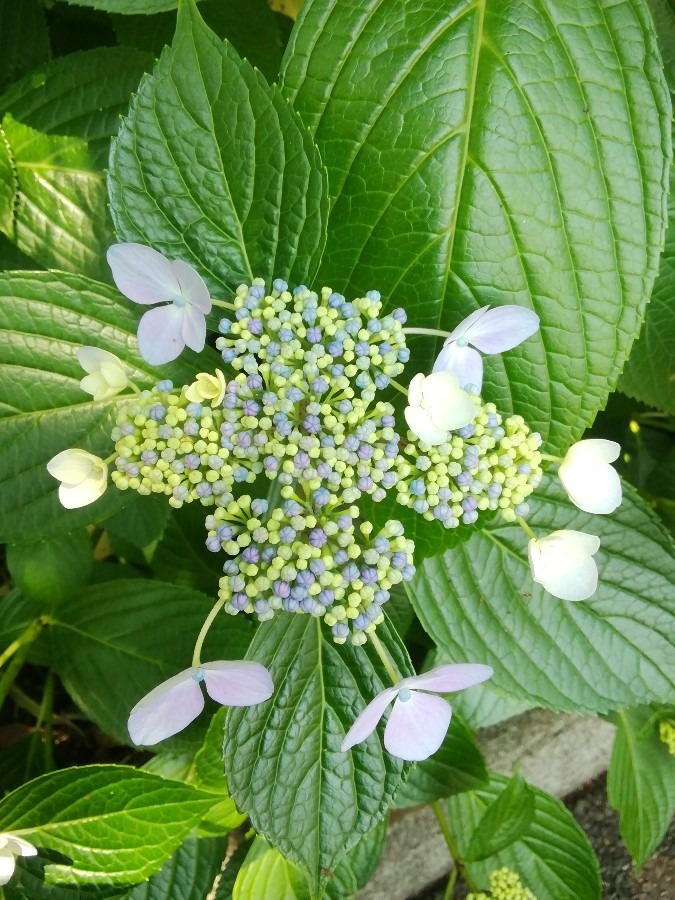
xmin=420 ymin=775 xmax=675 ymax=900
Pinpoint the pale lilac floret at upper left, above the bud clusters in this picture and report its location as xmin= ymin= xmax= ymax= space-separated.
xmin=107 ymin=243 xmax=211 ymax=366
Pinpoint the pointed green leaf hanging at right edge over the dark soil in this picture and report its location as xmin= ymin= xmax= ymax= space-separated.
xmin=607 ymin=706 xmax=675 ymax=868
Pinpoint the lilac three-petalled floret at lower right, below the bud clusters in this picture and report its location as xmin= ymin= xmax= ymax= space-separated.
xmin=340 ymin=663 xmax=493 ymax=762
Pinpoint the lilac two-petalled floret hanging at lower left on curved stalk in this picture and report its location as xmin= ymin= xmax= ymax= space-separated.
xmin=128 ymin=659 xmax=274 ymax=746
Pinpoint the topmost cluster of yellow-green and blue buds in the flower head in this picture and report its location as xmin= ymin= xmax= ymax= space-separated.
xmin=216 ymin=278 xmax=410 ymax=402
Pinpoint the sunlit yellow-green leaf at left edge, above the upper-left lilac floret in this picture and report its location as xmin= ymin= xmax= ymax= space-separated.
xmin=2 ymin=113 xmax=114 ymax=278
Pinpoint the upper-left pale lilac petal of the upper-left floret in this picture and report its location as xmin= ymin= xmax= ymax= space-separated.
xmin=107 ymin=243 xmax=181 ymax=304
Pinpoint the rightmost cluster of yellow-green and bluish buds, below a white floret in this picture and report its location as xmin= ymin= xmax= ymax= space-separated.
xmin=396 ymin=395 xmax=542 ymax=528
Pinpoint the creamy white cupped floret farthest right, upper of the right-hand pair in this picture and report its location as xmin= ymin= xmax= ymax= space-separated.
xmin=558 ymin=439 xmax=621 ymax=514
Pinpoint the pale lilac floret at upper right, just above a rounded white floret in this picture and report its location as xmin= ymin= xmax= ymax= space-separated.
xmin=433 ymin=304 xmax=539 ymax=393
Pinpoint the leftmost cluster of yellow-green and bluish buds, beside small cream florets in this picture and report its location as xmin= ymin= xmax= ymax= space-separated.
xmin=112 ymin=381 xmax=240 ymax=507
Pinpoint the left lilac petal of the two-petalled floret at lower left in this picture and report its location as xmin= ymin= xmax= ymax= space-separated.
xmin=127 ymin=666 xmax=204 ymax=746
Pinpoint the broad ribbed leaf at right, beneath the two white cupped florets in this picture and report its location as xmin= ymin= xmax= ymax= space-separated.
xmin=408 ymin=475 xmax=675 ymax=713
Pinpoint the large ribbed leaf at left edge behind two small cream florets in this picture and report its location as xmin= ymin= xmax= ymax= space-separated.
xmin=0 ymin=272 xmax=213 ymax=541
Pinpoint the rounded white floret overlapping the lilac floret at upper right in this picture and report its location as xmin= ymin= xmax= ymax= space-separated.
xmin=405 ymin=372 xmax=476 ymax=446
